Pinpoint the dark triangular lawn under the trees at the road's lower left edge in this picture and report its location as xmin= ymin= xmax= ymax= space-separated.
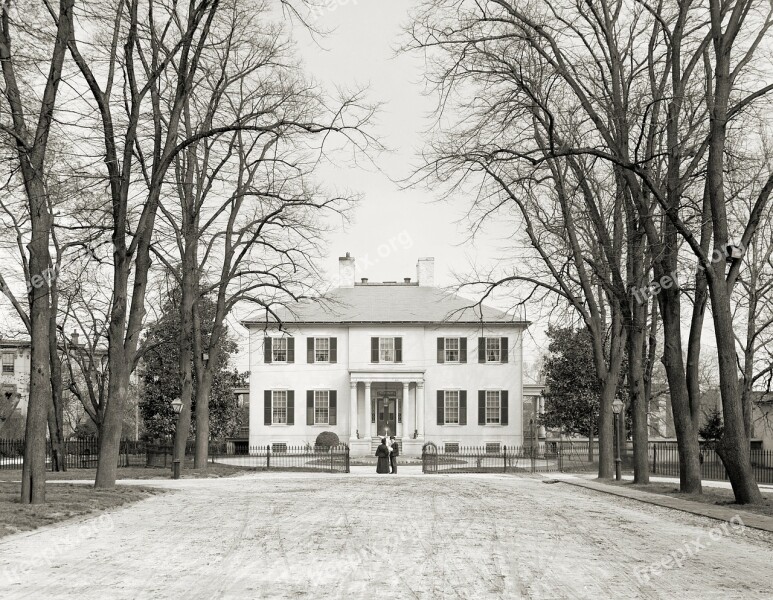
xmin=0 ymin=482 xmax=164 ymax=537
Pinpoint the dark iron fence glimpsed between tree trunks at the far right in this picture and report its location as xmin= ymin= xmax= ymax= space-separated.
xmin=649 ymin=443 xmax=773 ymax=483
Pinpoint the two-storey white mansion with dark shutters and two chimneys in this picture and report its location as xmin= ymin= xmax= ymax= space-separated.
xmin=244 ymin=254 xmax=541 ymax=456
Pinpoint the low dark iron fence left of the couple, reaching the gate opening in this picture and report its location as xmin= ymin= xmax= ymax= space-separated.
xmin=210 ymin=444 xmax=350 ymax=473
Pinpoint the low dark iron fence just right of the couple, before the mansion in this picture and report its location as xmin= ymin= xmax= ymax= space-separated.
xmin=421 ymin=442 xmax=592 ymax=473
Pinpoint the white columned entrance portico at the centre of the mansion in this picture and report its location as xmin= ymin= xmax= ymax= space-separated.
xmin=349 ymin=370 xmax=425 ymax=455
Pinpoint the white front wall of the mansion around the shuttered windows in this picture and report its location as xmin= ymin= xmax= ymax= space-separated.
xmin=250 ymin=325 xmax=523 ymax=447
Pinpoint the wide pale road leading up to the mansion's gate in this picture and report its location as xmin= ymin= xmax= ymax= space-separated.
xmin=0 ymin=468 xmax=773 ymax=600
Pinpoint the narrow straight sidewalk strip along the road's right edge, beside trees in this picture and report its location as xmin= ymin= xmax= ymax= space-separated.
xmin=543 ymin=473 xmax=773 ymax=533
